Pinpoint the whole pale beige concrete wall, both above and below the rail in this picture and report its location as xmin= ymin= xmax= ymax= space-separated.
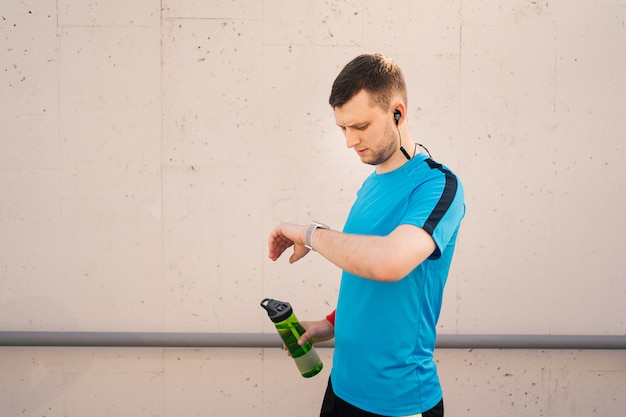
xmin=0 ymin=0 xmax=626 ymax=417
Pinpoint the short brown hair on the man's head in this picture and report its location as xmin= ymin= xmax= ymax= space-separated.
xmin=328 ymin=53 xmax=408 ymax=110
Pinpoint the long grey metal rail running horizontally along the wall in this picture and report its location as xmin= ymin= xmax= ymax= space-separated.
xmin=0 ymin=331 xmax=626 ymax=350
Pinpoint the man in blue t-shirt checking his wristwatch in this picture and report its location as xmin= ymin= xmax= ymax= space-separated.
xmin=269 ymin=54 xmax=465 ymax=417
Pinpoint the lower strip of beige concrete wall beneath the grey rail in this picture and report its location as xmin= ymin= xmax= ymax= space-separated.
xmin=0 ymin=348 xmax=626 ymax=417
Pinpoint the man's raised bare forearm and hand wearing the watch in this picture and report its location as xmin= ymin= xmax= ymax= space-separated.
xmin=269 ymin=223 xmax=435 ymax=282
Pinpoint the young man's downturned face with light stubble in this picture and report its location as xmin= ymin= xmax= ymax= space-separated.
xmin=334 ymin=90 xmax=399 ymax=169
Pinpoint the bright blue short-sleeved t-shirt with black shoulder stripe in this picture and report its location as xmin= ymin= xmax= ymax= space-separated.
xmin=331 ymin=153 xmax=465 ymax=416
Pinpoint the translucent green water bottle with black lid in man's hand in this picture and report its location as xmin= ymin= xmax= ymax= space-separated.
xmin=261 ymin=298 xmax=324 ymax=378
